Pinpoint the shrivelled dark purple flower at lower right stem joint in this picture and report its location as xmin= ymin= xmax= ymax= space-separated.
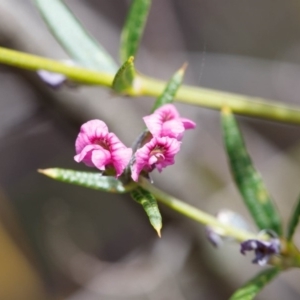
xmin=241 ymin=238 xmax=280 ymax=266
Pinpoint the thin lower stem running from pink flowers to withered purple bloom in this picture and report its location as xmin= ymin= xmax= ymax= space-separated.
xmin=139 ymin=177 xmax=257 ymax=242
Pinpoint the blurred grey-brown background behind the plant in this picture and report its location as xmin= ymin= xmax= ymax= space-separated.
xmin=0 ymin=0 xmax=300 ymax=300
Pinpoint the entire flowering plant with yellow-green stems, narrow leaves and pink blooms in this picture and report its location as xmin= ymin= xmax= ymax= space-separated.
xmin=0 ymin=0 xmax=300 ymax=300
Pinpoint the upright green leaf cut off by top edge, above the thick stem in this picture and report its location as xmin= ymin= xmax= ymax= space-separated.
xmin=120 ymin=0 xmax=151 ymax=62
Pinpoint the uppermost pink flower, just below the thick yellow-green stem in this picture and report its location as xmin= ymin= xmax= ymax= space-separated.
xmin=143 ymin=104 xmax=196 ymax=141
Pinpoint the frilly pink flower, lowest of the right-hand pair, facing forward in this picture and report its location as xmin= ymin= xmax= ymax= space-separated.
xmin=131 ymin=137 xmax=181 ymax=181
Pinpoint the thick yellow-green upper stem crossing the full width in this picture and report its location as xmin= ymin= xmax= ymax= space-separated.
xmin=0 ymin=47 xmax=300 ymax=124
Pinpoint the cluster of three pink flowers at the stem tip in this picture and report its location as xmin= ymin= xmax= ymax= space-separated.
xmin=74 ymin=104 xmax=196 ymax=181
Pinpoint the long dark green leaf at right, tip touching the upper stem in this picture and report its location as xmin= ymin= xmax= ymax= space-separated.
xmin=222 ymin=107 xmax=282 ymax=235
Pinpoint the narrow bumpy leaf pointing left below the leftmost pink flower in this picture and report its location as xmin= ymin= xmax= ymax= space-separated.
xmin=38 ymin=168 xmax=136 ymax=193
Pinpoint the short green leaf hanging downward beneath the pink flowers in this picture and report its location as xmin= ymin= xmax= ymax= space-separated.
xmin=130 ymin=187 xmax=162 ymax=237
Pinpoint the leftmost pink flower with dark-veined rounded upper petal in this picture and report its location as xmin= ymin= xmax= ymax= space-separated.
xmin=74 ymin=120 xmax=132 ymax=177
